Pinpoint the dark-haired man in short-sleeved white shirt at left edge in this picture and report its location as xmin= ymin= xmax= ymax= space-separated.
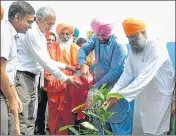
xmin=0 ymin=1 xmax=35 ymax=135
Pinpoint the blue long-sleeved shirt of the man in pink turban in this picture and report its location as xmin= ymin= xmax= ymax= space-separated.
xmin=78 ymin=35 xmax=127 ymax=88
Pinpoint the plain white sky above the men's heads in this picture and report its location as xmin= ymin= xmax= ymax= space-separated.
xmin=1 ymin=1 xmax=175 ymax=43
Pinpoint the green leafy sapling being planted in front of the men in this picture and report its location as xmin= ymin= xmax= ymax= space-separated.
xmin=59 ymin=84 xmax=123 ymax=135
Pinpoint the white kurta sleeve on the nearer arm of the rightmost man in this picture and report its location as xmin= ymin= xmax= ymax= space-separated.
xmin=110 ymin=42 xmax=167 ymax=102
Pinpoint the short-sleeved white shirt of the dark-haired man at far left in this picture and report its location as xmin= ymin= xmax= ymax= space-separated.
xmin=1 ymin=21 xmax=18 ymax=85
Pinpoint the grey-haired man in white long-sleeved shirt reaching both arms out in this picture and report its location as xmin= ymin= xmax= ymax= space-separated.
xmin=16 ymin=7 xmax=78 ymax=135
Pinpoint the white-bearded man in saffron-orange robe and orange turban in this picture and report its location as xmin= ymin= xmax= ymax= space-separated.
xmin=45 ymin=24 xmax=93 ymax=135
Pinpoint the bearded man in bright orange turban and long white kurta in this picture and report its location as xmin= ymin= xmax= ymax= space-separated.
xmin=105 ymin=18 xmax=174 ymax=135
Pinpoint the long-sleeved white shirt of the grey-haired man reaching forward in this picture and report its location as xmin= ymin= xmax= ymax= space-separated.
xmin=17 ymin=22 xmax=68 ymax=81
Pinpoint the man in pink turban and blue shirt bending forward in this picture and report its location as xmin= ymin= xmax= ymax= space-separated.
xmin=78 ymin=19 xmax=132 ymax=135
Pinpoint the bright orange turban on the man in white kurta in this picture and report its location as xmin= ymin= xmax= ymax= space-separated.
xmin=122 ymin=18 xmax=146 ymax=35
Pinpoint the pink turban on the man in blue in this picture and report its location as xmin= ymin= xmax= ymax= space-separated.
xmin=90 ymin=19 xmax=113 ymax=38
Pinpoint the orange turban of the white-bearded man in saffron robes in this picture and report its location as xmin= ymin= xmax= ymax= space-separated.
xmin=56 ymin=24 xmax=74 ymax=35
